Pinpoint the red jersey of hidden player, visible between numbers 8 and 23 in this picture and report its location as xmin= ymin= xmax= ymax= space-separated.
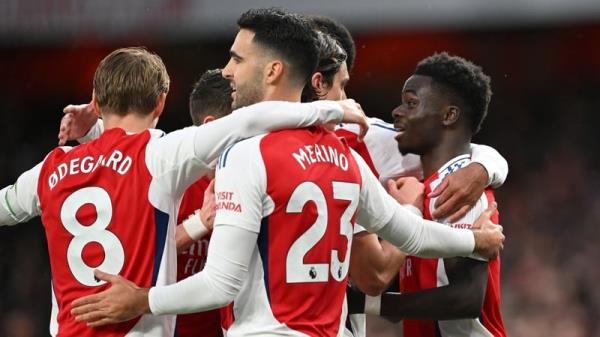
xmin=176 ymin=176 xmax=223 ymax=337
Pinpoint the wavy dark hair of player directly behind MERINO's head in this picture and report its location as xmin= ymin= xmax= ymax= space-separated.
xmin=302 ymin=31 xmax=346 ymax=102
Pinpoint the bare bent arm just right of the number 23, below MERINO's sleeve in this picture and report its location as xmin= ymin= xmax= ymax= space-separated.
xmin=349 ymin=231 xmax=406 ymax=296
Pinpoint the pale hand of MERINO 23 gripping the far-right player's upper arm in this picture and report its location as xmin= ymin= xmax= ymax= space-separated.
xmin=472 ymin=202 xmax=504 ymax=259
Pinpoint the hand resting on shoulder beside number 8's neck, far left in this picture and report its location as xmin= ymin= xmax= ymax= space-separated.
xmin=58 ymin=102 xmax=98 ymax=146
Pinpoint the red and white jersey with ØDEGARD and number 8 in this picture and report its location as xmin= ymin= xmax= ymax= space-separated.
xmin=37 ymin=129 xmax=212 ymax=336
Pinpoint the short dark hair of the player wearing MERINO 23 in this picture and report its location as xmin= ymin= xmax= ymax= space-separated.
xmin=237 ymin=8 xmax=319 ymax=85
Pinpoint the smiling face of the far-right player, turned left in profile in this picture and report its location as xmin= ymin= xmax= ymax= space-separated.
xmin=392 ymin=75 xmax=443 ymax=155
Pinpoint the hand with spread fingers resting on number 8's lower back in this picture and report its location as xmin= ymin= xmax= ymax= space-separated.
xmin=71 ymin=270 xmax=150 ymax=327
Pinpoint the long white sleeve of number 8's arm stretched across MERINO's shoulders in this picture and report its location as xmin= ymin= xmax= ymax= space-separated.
xmin=146 ymin=101 xmax=343 ymax=196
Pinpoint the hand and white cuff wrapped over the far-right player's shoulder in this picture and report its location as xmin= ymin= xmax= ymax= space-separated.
xmin=429 ymin=144 xmax=508 ymax=221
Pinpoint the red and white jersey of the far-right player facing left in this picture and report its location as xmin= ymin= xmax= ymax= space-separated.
xmin=400 ymin=155 xmax=506 ymax=337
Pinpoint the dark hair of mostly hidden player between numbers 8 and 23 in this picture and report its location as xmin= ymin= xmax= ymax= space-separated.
xmin=189 ymin=69 xmax=232 ymax=125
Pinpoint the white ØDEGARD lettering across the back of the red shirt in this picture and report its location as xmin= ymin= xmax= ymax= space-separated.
xmin=48 ymin=150 xmax=133 ymax=190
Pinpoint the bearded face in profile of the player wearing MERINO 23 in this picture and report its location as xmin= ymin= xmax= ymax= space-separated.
xmin=223 ymin=29 xmax=264 ymax=109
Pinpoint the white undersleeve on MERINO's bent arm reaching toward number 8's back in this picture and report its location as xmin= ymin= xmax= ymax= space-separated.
xmin=148 ymin=225 xmax=258 ymax=315
